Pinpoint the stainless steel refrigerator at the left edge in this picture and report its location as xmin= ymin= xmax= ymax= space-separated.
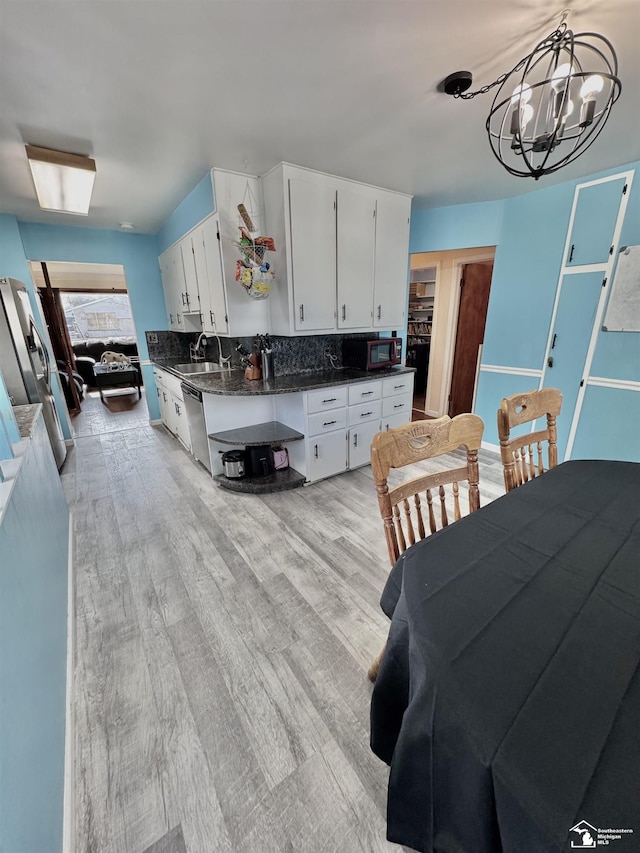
xmin=0 ymin=278 xmax=67 ymax=470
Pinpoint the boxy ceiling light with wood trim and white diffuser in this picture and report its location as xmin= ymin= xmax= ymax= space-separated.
xmin=25 ymin=145 xmax=96 ymax=216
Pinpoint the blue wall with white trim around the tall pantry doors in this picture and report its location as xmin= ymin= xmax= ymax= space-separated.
xmin=410 ymin=162 xmax=640 ymax=460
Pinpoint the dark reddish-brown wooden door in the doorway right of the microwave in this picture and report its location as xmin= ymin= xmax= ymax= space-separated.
xmin=449 ymin=261 xmax=493 ymax=418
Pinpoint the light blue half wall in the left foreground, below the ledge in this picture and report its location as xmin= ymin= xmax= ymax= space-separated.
xmin=0 ymin=417 xmax=69 ymax=853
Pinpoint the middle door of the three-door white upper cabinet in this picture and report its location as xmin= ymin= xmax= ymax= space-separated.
xmin=337 ymin=188 xmax=376 ymax=329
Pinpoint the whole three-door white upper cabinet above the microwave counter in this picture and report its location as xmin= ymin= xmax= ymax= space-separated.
xmin=262 ymin=163 xmax=411 ymax=335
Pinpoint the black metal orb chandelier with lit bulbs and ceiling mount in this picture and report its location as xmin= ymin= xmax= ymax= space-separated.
xmin=443 ymin=11 xmax=621 ymax=180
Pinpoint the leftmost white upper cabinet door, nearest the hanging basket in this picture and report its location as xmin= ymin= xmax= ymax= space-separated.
xmin=289 ymin=178 xmax=336 ymax=331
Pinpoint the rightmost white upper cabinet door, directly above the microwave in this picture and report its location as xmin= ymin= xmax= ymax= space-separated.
xmin=373 ymin=193 xmax=411 ymax=329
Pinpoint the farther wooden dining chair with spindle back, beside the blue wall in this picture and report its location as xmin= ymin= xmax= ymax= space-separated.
xmin=498 ymin=388 xmax=562 ymax=492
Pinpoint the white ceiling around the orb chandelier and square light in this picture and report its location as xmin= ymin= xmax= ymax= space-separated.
xmin=0 ymin=0 xmax=640 ymax=233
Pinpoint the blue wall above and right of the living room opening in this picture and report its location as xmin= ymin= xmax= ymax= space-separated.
xmin=19 ymin=222 xmax=167 ymax=419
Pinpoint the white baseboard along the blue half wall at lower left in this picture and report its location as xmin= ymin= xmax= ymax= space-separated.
xmin=62 ymin=513 xmax=76 ymax=853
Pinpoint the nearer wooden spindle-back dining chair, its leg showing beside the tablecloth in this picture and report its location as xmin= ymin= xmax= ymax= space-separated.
xmin=368 ymin=414 xmax=484 ymax=681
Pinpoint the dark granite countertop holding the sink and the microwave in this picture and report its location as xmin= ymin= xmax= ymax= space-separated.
xmin=153 ymin=358 xmax=415 ymax=397
